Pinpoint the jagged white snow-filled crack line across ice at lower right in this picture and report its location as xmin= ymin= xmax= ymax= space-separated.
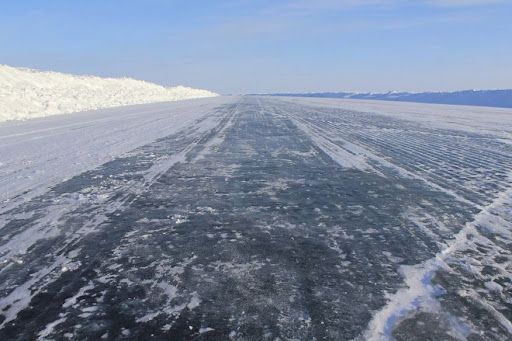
xmin=362 ymin=175 xmax=512 ymax=340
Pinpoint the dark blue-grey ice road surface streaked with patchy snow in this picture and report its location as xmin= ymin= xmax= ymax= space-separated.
xmin=0 ymin=97 xmax=512 ymax=340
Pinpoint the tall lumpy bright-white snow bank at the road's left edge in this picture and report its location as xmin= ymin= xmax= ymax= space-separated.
xmin=0 ymin=65 xmax=217 ymax=122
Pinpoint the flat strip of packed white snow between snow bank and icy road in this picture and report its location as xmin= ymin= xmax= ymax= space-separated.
xmin=0 ymin=97 xmax=232 ymax=212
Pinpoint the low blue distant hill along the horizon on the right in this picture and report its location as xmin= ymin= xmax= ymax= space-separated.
xmin=271 ymin=89 xmax=512 ymax=108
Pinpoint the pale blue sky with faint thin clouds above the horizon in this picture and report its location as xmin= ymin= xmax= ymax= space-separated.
xmin=0 ymin=0 xmax=512 ymax=93
